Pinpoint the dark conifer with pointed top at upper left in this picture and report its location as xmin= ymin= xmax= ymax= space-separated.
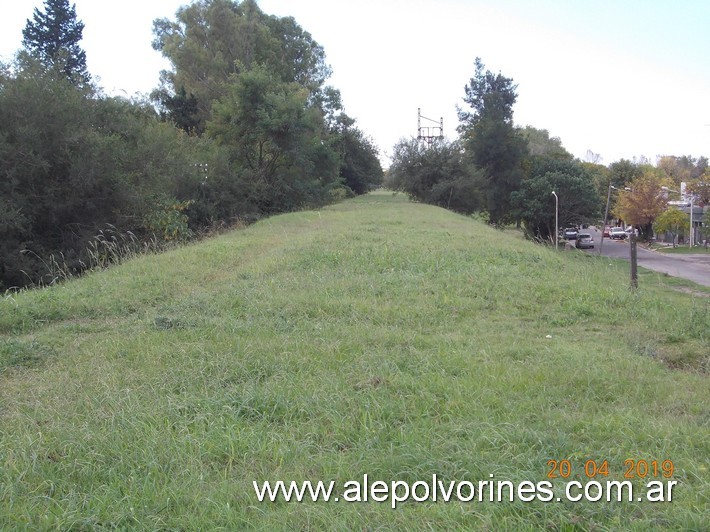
xmin=22 ymin=0 xmax=91 ymax=86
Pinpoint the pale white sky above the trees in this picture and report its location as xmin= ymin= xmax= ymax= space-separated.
xmin=0 ymin=0 xmax=710 ymax=164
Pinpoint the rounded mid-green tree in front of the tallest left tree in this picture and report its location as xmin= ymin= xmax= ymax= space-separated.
xmin=207 ymin=66 xmax=338 ymax=214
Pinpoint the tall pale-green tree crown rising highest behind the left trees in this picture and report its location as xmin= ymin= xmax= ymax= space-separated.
xmin=153 ymin=0 xmax=330 ymax=134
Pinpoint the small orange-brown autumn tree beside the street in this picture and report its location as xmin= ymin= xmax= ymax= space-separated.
xmin=612 ymin=167 xmax=667 ymax=239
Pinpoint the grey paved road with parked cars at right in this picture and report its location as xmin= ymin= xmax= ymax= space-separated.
xmin=586 ymin=229 xmax=710 ymax=286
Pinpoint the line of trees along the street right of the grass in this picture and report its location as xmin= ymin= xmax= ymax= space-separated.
xmin=387 ymin=58 xmax=710 ymax=240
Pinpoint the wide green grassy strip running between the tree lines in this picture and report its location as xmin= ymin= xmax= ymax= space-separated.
xmin=0 ymin=193 xmax=710 ymax=530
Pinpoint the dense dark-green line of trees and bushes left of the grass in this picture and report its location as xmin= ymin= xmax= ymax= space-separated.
xmin=0 ymin=0 xmax=383 ymax=289
